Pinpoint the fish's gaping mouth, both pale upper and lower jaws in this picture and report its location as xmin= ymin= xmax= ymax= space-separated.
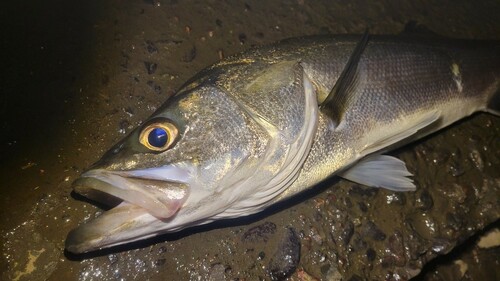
xmin=66 ymin=169 xmax=189 ymax=253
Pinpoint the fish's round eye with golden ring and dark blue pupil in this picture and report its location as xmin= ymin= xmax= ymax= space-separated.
xmin=139 ymin=119 xmax=178 ymax=151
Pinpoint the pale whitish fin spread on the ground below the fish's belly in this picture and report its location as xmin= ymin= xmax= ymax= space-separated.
xmin=339 ymin=155 xmax=415 ymax=191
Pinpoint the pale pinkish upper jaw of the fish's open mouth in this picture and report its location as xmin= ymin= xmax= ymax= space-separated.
xmin=73 ymin=169 xmax=189 ymax=219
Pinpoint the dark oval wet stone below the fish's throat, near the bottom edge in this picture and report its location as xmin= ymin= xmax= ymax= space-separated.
xmin=268 ymin=228 xmax=300 ymax=280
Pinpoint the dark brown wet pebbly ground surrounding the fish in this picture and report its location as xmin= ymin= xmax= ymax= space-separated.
xmin=0 ymin=0 xmax=500 ymax=280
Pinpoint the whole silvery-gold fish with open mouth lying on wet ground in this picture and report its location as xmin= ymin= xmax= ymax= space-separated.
xmin=65 ymin=32 xmax=500 ymax=254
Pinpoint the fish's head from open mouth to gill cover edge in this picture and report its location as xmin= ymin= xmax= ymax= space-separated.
xmin=66 ymin=60 xmax=317 ymax=253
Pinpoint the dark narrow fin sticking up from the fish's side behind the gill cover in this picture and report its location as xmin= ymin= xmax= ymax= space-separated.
xmin=320 ymin=29 xmax=369 ymax=125
